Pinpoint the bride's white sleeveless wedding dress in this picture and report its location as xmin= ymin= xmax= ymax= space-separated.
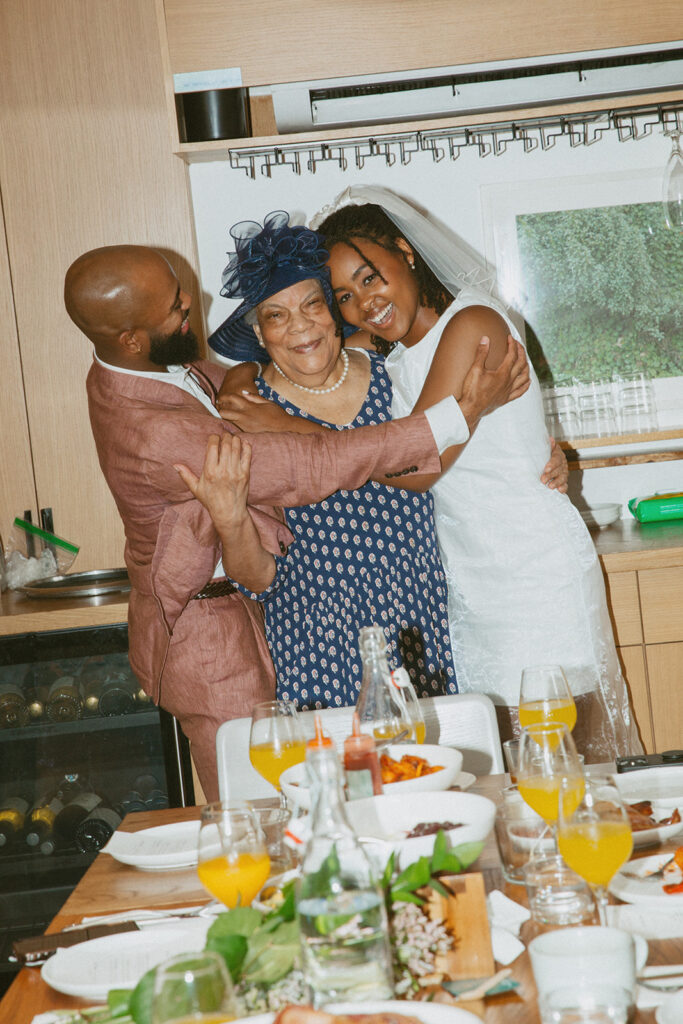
xmin=386 ymin=288 xmax=641 ymax=761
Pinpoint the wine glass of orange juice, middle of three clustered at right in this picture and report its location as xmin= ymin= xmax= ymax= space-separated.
xmin=517 ymin=723 xmax=585 ymax=839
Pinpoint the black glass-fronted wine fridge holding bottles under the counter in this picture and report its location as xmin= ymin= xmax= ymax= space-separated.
xmin=0 ymin=625 xmax=195 ymax=994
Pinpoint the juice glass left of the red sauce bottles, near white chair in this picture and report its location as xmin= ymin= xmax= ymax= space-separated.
xmin=249 ymin=700 xmax=306 ymax=791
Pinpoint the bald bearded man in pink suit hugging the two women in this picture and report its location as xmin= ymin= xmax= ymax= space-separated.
xmin=65 ymin=246 xmax=528 ymax=800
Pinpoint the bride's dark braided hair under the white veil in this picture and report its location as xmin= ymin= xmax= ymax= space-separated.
xmin=317 ymin=203 xmax=453 ymax=355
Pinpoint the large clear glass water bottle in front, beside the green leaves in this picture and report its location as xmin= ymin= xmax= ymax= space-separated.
xmin=297 ymin=719 xmax=393 ymax=1008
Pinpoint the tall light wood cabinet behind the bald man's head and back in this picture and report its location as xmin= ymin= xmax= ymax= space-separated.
xmin=0 ymin=0 xmax=197 ymax=569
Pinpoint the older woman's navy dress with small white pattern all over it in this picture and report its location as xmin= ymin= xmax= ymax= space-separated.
xmin=241 ymin=352 xmax=458 ymax=709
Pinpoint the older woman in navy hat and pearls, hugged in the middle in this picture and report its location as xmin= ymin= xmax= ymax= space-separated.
xmin=205 ymin=215 xmax=471 ymax=708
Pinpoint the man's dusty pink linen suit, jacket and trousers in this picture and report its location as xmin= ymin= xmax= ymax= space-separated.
xmin=86 ymin=359 xmax=440 ymax=800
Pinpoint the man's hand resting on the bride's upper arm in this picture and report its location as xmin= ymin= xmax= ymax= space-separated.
xmin=460 ymin=335 xmax=529 ymax=430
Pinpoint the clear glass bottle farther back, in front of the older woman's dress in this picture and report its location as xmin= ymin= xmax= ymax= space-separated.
xmin=355 ymin=626 xmax=413 ymax=741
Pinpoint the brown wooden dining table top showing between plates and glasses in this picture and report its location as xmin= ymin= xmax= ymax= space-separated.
xmin=0 ymin=766 xmax=683 ymax=1024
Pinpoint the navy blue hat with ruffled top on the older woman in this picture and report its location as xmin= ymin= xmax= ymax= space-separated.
xmin=209 ymin=210 xmax=334 ymax=362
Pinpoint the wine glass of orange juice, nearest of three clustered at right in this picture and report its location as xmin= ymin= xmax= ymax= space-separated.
xmin=558 ymin=776 xmax=633 ymax=927
